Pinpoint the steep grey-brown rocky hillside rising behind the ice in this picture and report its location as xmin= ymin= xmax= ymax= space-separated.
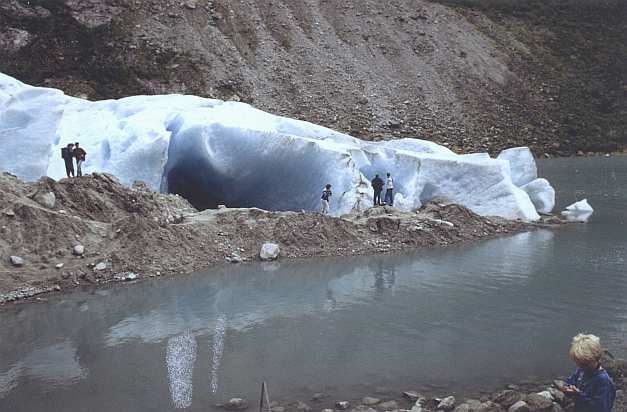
xmin=0 ymin=0 xmax=627 ymax=155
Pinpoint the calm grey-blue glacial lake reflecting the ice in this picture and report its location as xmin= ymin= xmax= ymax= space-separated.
xmin=0 ymin=157 xmax=627 ymax=412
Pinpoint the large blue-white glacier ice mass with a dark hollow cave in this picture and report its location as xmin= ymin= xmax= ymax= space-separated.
xmin=0 ymin=73 xmax=555 ymax=220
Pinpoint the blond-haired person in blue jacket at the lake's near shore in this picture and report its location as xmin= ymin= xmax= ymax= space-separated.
xmin=561 ymin=333 xmax=616 ymax=412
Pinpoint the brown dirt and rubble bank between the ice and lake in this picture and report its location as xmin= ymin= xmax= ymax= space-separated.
xmin=0 ymin=173 xmax=560 ymax=303
